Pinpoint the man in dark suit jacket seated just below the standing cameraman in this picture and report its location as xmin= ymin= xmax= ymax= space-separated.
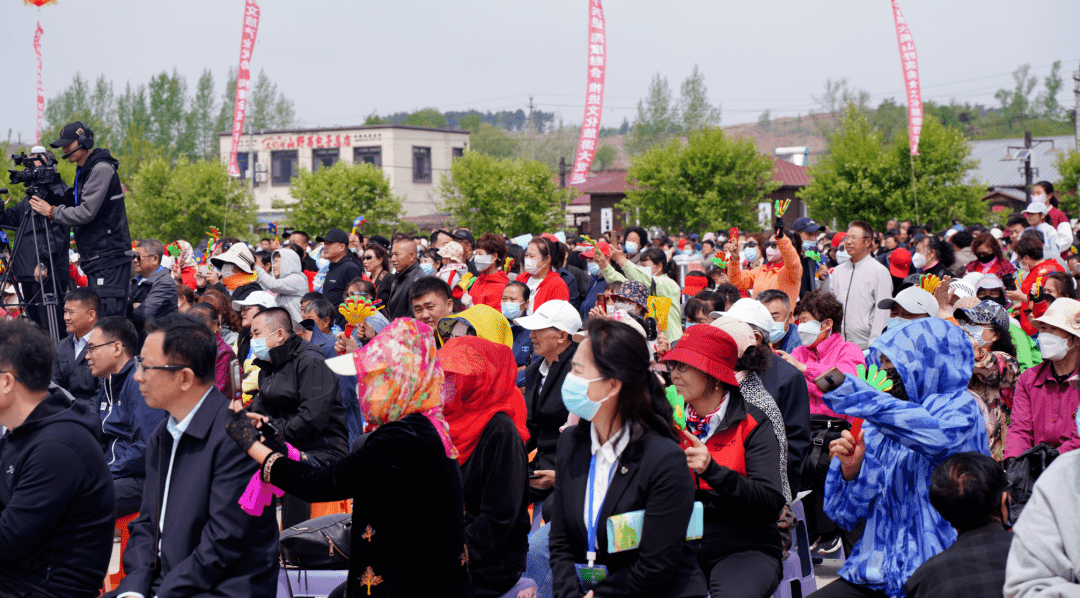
xmin=53 ymin=287 xmax=102 ymax=406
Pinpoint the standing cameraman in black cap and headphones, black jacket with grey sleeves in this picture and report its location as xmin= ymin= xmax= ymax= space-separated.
xmin=30 ymin=121 xmax=132 ymax=317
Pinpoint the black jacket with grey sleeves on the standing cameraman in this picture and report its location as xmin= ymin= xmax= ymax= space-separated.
xmin=53 ymin=148 xmax=132 ymax=275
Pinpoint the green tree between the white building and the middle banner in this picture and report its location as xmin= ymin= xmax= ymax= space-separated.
xmin=437 ymin=151 xmax=569 ymax=236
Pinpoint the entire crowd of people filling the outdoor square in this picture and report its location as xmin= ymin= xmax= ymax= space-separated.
xmin=0 ymin=123 xmax=1080 ymax=598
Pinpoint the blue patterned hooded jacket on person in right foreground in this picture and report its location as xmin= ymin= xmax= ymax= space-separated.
xmin=823 ymin=317 xmax=989 ymax=598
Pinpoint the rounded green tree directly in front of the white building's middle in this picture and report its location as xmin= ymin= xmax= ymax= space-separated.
xmin=273 ymin=160 xmax=403 ymax=234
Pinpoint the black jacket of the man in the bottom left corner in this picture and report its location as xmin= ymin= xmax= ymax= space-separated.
xmin=0 ymin=392 xmax=116 ymax=597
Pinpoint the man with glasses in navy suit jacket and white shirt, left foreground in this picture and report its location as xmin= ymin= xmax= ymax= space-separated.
xmin=110 ymin=314 xmax=278 ymax=598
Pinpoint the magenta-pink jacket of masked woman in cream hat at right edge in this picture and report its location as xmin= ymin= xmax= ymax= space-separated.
xmin=1004 ymin=362 xmax=1080 ymax=459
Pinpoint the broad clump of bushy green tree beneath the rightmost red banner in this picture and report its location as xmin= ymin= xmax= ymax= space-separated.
xmin=798 ymin=104 xmax=988 ymax=229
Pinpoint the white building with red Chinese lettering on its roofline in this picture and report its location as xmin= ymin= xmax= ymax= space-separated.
xmin=218 ymin=124 xmax=469 ymax=220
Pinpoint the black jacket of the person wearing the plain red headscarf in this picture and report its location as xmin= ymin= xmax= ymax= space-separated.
xmin=461 ymin=413 xmax=530 ymax=597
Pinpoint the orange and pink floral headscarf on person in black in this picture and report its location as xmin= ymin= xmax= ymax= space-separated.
xmin=352 ymin=317 xmax=458 ymax=459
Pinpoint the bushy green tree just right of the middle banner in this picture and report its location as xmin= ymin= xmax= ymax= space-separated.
xmin=619 ymin=128 xmax=780 ymax=231
